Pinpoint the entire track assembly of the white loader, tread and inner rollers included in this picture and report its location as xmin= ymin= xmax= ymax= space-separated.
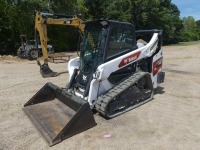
xmin=95 ymin=71 xmax=154 ymax=118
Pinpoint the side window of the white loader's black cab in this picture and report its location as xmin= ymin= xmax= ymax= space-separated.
xmin=107 ymin=27 xmax=133 ymax=58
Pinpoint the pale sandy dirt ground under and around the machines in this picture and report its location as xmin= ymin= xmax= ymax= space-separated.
xmin=0 ymin=45 xmax=200 ymax=150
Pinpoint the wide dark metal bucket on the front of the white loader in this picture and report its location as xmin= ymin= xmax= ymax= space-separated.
xmin=23 ymin=83 xmax=96 ymax=146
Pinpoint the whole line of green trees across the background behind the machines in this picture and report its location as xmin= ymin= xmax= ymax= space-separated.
xmin=0 ymin=0 xmax=200 ymax=54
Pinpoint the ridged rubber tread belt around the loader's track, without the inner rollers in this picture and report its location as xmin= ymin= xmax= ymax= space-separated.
xmin=95 ymin=71 xmax=153 ymax=118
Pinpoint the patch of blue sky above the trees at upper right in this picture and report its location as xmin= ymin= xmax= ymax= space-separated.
xmin=172 ymin=0 xmax=200 ymax=20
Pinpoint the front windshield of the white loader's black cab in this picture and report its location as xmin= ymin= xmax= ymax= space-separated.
xmin=80 ymin=25 xmax=102 ymax=73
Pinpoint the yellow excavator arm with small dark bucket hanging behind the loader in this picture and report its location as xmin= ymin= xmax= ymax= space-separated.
xmin=35 ymin=12 xmax=84 ymax=78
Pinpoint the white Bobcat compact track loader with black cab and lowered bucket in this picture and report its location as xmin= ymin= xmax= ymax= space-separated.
xmin=23 ymin=20 xmax=165 ymax=146
